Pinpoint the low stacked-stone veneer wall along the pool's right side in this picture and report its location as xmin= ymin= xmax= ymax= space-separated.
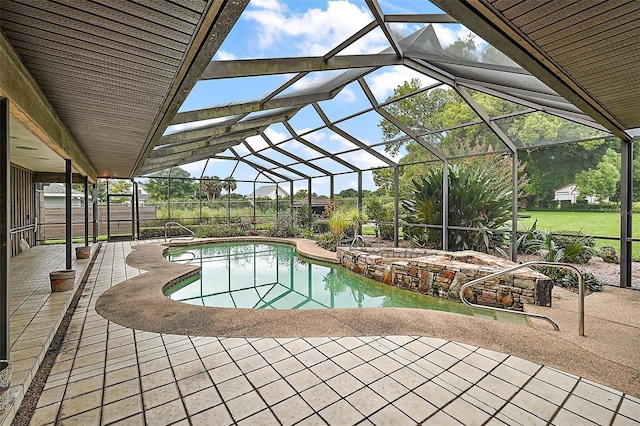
xmin=337 ymin=247 xmax=553 ymax=311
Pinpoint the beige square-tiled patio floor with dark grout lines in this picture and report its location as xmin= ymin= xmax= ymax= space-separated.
xmin=0 ymin=242 xmax=640 ymax=425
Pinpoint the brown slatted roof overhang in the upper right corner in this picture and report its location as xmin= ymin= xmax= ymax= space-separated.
xmin=433 ymin=0 xmax=640 ymax=141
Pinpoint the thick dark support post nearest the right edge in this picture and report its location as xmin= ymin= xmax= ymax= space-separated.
xmin=620 ymin=141 xmax=633 ymax=288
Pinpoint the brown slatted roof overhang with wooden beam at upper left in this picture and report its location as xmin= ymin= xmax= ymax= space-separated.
xmin=0 ymin=0 xmax=248 ymax=180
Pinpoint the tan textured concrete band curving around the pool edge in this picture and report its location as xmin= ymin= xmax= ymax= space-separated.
xmin=96 ymin=237 xmax=640 ymax=395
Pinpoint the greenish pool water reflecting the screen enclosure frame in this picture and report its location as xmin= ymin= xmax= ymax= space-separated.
xmin=165 ymin=243 xmax=526 ymax=324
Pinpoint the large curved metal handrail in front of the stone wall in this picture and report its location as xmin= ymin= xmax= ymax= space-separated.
xmin=460 ymin=260 xmax=584 ymax=336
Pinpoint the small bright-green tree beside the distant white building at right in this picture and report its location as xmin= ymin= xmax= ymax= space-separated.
xmin=575 ymin=149 xmax=620 ymax=200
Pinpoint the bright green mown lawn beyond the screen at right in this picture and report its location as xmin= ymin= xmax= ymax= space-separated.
xmin=518 ymin=211 xmax=640 ymax=260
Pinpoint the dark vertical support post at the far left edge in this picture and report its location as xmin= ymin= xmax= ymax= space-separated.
xmin=0 ymin=97 xmax=11 ymax=361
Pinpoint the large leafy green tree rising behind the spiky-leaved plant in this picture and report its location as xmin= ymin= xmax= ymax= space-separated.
xmin=373 ymin=36 xmax=608 ymax=207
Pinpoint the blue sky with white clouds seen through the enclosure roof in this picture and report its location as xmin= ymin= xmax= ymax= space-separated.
xmin=169 ymin=0 xmax=480 ymax=195
